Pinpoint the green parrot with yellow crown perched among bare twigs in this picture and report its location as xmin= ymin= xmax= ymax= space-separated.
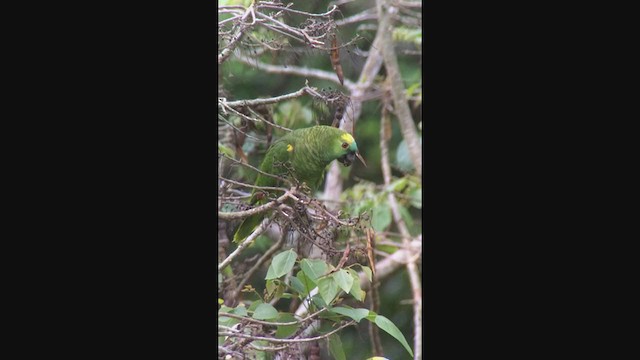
xmin=233 ymin=125 xmax=367 ymax=243
